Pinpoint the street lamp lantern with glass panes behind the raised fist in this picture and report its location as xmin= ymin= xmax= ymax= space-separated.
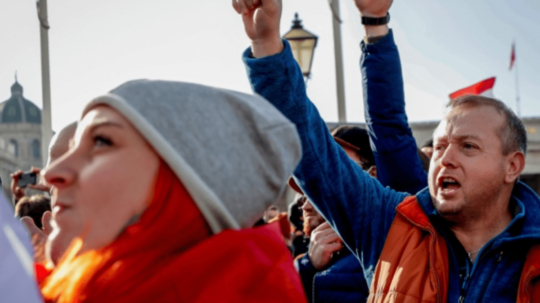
xmin=283 ymin=13 xmax=319 ymax=78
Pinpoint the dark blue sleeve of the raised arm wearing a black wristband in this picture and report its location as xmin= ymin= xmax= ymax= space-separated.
xmin=360 ymin=31 xmax=427 ymax=194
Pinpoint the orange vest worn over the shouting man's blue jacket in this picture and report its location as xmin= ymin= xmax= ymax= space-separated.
xmin=367 ymin=196 xmax=540 ymax=303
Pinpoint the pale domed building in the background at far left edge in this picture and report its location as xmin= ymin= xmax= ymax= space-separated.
xmin=0 ymin=79 xmax=42 ymax=201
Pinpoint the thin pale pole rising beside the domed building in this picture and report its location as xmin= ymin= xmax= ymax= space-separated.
xmin=36 ymin=0 xmax=52 ymax=166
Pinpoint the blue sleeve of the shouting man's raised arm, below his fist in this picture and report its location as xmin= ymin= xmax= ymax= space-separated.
xmin=243 ymin=41 xmax=406 ymax=280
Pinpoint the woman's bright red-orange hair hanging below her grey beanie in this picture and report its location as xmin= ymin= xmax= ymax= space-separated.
xmin=42 ymin=162 xmax=211 ymax=303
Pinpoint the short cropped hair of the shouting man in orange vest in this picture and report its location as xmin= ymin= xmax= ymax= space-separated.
xmin=447 ymin=95 xmax=527 ymax=155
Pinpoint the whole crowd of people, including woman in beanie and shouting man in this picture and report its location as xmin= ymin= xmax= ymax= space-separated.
xmin=0 ymin=0 xmax=540 ymax=303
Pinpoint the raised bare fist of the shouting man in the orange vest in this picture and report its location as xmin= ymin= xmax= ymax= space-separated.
xmin=232 ymin=0 xmax=283 ymax=58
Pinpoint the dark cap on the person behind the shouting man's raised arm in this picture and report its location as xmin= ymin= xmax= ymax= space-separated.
xmin=332 ymin=125 xmax=375 ymax=166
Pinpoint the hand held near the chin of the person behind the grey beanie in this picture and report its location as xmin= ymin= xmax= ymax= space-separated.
xmin=308 ymin=222 xmax=343 ymax=270
